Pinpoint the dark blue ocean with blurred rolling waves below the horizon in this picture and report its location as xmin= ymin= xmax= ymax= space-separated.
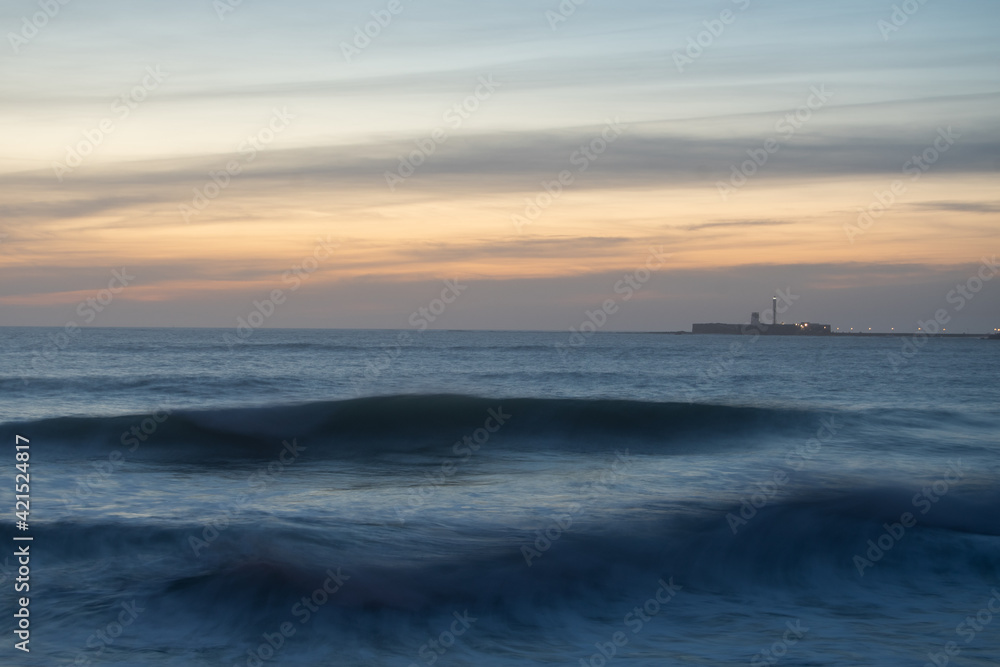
xmin=0 ymin=328 xmax=1000 ymax=667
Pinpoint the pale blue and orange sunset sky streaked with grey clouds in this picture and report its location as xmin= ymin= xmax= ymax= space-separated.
xmin=0 ymin=0 xmax=1000 ymax=332
